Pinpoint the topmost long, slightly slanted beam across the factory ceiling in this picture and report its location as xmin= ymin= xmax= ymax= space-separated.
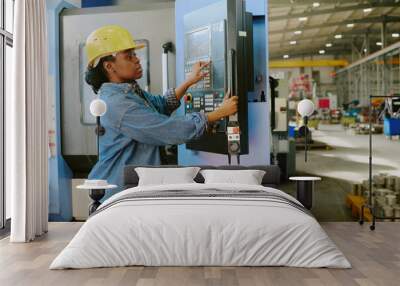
xmin=268 ymin=1 xmax=399 ymax=22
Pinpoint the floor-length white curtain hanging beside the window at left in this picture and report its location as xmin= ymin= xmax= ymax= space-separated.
xmin=6 ymin=0 xmax=48 ymax=242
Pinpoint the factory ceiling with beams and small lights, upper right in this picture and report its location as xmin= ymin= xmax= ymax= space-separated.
xmin=268 ymin=0 xmax=400 ymax=60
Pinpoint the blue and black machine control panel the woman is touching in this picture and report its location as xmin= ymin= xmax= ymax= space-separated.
xmin=184 ymin=0 xmax=253 ymax=155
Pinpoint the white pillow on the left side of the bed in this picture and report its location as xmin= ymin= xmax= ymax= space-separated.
xmin=135 ymin=167 xmax=200 ymax=186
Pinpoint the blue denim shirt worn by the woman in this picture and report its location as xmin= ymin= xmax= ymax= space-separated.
xmin=89 ymin=83 xmax=207 ymax=199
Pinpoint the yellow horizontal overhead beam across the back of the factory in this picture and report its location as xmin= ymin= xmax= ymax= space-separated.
xmin=269 ymin=60 xmax=349 ymax=69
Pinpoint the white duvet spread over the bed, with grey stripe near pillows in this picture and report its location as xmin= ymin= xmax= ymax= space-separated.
xmin=50 ymin=183 xmax=351 ymax=269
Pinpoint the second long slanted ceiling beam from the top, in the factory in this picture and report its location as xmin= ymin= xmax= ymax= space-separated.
xmin=269 ymin=16 xmax=400 ymax=35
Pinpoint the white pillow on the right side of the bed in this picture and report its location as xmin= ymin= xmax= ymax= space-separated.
xmin=200 ymin=170 xmax=265 ymax=185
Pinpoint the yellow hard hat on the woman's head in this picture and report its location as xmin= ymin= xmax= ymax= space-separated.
xmin=86 ymin=25 xmax=144 ymax=66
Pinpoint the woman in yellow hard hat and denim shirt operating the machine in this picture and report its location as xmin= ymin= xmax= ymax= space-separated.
xmin=86 ymin=26 xmax=238 ymax=197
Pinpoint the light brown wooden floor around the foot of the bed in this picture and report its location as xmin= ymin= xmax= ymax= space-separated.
xmin=0 ymin=222 xmax=400 ymax=286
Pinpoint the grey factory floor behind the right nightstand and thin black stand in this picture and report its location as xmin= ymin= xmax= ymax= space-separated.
xmin=281 ymin=125 xmax=400 ymax=221
